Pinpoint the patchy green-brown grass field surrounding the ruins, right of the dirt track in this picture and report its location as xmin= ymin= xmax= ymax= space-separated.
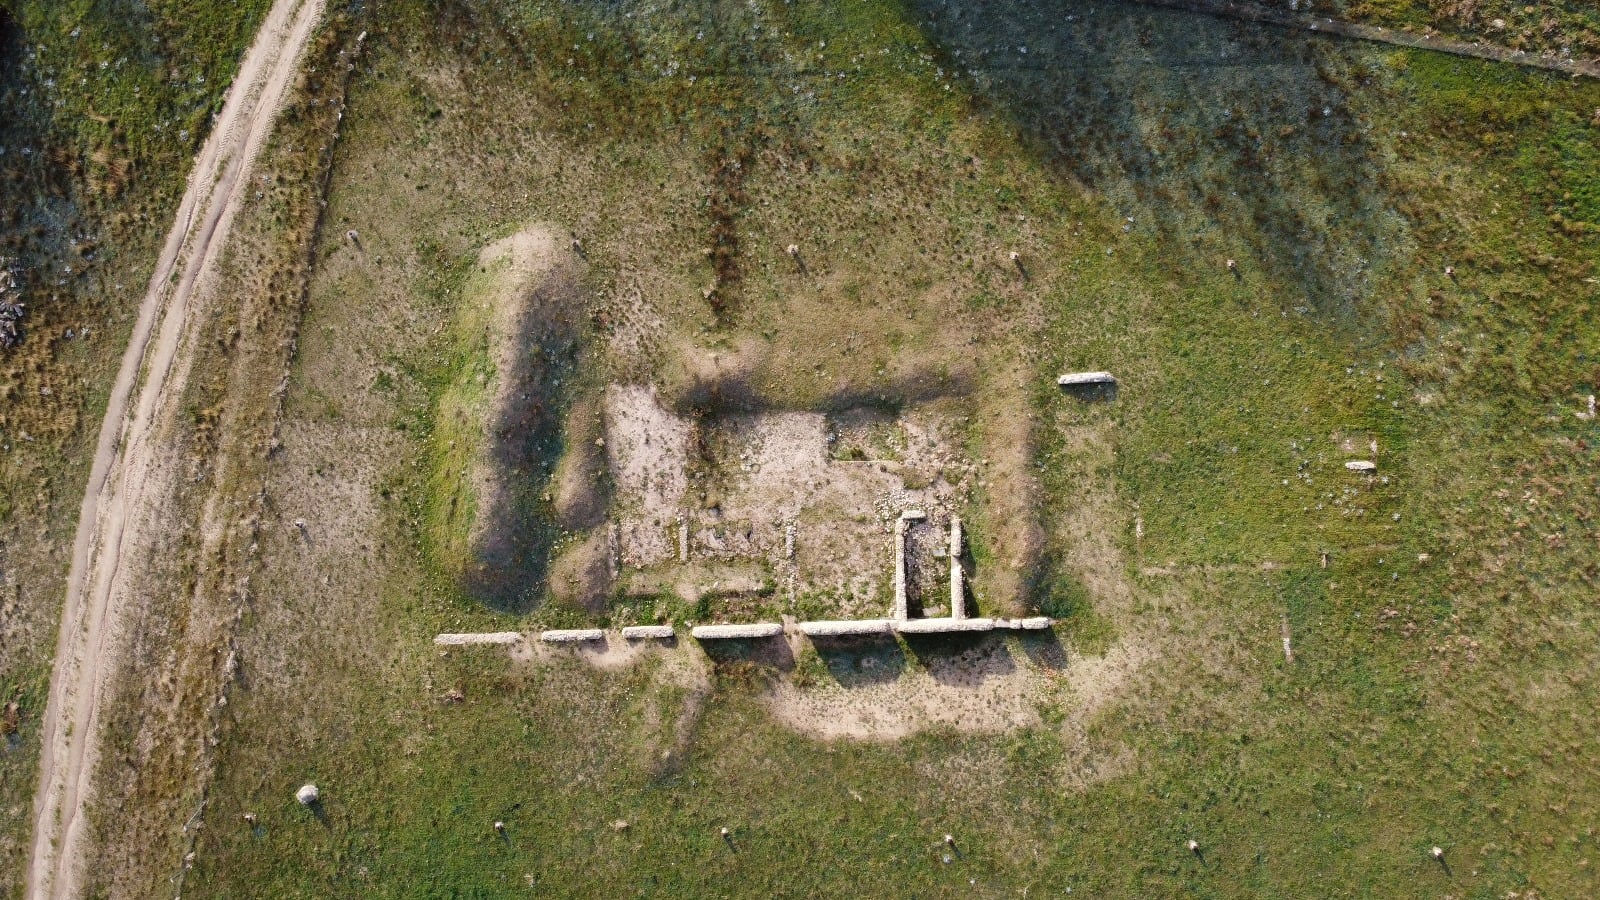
xmin=0 ymin=0 xmax=1600 ymax=897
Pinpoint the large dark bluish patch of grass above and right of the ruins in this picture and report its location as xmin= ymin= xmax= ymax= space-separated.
xmin=906 ymin=0 xmax=1398 ymax=314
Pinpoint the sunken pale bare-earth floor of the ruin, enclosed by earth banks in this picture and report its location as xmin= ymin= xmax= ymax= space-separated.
xmin=605 ymin=386 xmax=974 ymax=618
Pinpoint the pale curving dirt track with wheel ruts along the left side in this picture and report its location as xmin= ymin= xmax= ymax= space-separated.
xmin=27 ymin=0 xmax=323 ymax=897
